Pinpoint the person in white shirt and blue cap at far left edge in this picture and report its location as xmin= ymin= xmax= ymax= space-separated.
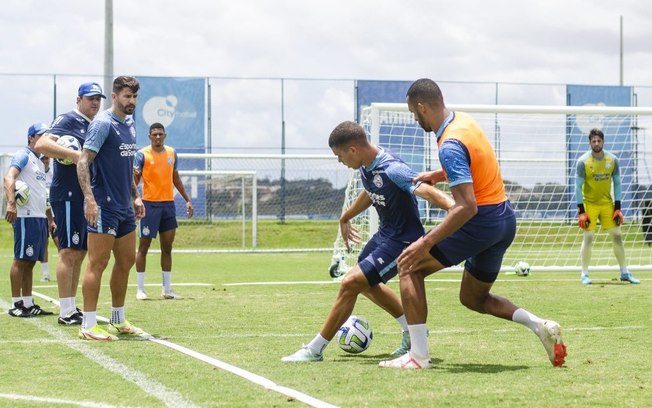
xmin=4 ymin=123 xmax=54 ymax=317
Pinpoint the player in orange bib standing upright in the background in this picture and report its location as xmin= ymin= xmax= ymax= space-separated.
xmin=134 ymin=123 xmax=193 ymax=300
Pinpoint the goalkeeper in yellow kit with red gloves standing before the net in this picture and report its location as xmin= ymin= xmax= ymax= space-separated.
xmin=575 ymin=129 xmax=640 ymax=285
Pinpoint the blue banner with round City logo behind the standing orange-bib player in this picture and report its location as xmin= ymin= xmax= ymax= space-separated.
xmin=134 ymin=77 xmax=207 ymax=218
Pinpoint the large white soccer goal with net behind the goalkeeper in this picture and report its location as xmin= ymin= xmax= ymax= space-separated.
xmin=330 ymin=103 xmax=652 ymax=277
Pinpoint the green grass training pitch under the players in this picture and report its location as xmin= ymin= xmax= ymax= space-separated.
xmin=0 ymin=222 xmax=652 ymax=407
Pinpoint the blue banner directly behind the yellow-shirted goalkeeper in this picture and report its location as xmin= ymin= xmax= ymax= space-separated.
xmin=566 ymin=85 xmax=636 ymax=219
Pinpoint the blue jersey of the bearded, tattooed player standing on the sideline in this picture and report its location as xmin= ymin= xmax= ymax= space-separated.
xmin=84 ymin=110 xmax=136 ymax=210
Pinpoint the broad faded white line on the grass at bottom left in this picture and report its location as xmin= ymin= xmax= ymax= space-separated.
xmin=0 ymin=292 xmax=196 ymax=407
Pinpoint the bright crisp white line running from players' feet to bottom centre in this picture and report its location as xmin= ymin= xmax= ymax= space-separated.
xmin=29 ymin=291 xmax=337 ymax=408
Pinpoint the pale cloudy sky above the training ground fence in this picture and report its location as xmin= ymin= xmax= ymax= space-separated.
xmin=0 ymin=0 xmax=652 ymax=153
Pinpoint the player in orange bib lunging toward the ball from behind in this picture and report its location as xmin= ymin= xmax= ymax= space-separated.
xmin=380 ymin=78 xmax=566 ymax=369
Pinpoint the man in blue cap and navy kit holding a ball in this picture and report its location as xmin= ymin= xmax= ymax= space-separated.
xmin=36 ymin=82 xmax=106 ymax=326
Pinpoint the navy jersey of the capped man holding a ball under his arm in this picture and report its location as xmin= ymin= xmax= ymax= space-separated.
xmin=48 ymin=109 xmax=91 ymax=202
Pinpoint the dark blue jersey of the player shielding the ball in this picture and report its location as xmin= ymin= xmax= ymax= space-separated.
xmin=360 ymin=148 xmax=425 ymax=242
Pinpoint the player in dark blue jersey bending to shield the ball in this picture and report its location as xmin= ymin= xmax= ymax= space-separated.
xmin=281 ymin=121 xmax=455 ymax=362
